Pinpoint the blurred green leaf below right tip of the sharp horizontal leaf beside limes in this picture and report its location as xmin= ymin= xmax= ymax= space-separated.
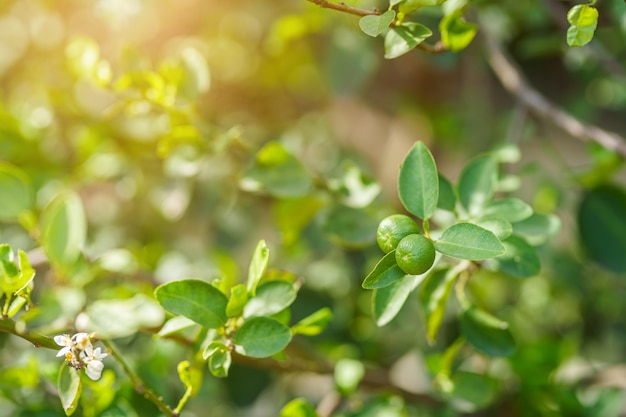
xmin=486 ymin=235 xmax=541 ymax=278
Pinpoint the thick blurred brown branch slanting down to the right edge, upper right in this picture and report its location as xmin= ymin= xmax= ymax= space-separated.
xmin=483 ymin=25 xmax=626 ymax=157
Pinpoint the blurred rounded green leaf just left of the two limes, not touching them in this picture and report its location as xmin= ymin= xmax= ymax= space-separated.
xmin=322 ymin=206 xmax=378 ymax=248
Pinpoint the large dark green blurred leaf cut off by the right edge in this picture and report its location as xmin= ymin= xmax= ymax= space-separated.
xmin=577 ymin=184 xmax=626 ymax=273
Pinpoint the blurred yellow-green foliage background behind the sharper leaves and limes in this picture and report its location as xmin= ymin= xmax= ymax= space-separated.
xmin=0 ymin=0 xmax=626 ymax=417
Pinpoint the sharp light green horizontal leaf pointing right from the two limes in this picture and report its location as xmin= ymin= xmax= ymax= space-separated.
xmin=434 ymin=223 xmax=504 ymax=261
